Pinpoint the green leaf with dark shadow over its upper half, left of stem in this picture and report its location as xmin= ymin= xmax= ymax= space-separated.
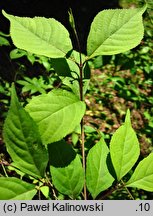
xmin=48 ymin=140 xmax=84 ymax=199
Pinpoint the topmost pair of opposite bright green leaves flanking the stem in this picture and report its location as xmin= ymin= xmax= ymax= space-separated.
xmin=3 ymin=5 xmax=146 ymax=61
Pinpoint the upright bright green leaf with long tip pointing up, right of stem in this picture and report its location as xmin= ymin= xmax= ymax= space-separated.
xmin=110 ymin=110 xmax=140 ymax=180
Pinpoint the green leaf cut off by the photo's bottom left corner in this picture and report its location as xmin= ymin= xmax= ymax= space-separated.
xmin=0 ymin=177 xmax=37 ymax=200
